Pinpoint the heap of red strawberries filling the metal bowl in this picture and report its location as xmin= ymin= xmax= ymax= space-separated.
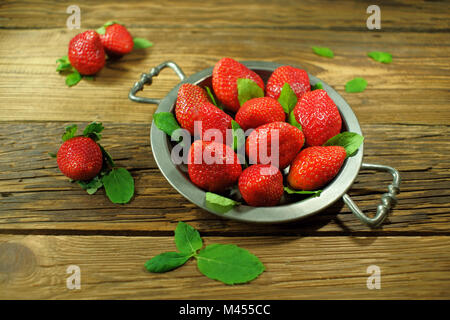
xmin=175 ymin=58 xmax=346 ymax=206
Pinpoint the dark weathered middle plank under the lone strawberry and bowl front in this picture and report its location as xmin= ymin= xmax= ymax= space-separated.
xmin=0 ymin=122 xmax=450 ymax=235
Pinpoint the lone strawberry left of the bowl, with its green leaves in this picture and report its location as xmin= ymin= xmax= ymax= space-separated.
xmin=51 ymin=122 xmax=134 ymax=203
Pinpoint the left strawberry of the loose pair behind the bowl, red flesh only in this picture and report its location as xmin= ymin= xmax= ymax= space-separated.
xmin=68 ymin=30 xmax=105 ymax=75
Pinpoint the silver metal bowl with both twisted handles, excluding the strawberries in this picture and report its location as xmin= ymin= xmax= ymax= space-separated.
xmin=129 ymin=61 xmax=400 ymax=227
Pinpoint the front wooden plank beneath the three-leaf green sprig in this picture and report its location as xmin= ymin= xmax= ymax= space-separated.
xmin=0 ymin=235 xmax=450 ymax=299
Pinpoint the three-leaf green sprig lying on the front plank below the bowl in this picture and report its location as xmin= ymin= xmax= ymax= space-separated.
xmin=144 ymin=221 xmax=265 ymax=285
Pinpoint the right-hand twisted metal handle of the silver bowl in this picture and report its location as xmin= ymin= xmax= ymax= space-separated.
xmin=342 ymin=163 xmax=400 ymax=228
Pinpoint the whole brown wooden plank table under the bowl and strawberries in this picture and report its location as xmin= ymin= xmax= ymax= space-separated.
xmin=0 ymin=0 xmax=450 ymax=299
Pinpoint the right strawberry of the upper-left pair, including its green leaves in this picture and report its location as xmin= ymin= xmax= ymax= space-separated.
xmin=96 ymin=21 xmax=153 ymax=58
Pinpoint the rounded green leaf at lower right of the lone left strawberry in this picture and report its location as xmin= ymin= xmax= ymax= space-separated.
xmin=102 ymin=168 xmax=134 ymax=203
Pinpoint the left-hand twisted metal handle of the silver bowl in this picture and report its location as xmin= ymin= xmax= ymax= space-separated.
xmin=128 ymin=61 xmax=186 ymax=104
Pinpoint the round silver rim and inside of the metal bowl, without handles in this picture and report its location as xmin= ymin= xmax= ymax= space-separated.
xmin=150 ymin=61 xmax=363 ymax=223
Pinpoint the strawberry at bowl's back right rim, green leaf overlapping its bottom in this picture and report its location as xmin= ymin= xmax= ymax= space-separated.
xmin=266 ymin=66 xmax=311 ymax=100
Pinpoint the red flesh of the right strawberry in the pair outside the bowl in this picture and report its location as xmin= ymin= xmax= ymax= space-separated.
xmin=99 ymin=23 xmax=134 ymax=57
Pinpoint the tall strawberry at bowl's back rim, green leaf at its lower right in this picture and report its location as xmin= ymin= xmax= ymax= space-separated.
xmin=212 ymin=58 xmax=264 ymax=112
